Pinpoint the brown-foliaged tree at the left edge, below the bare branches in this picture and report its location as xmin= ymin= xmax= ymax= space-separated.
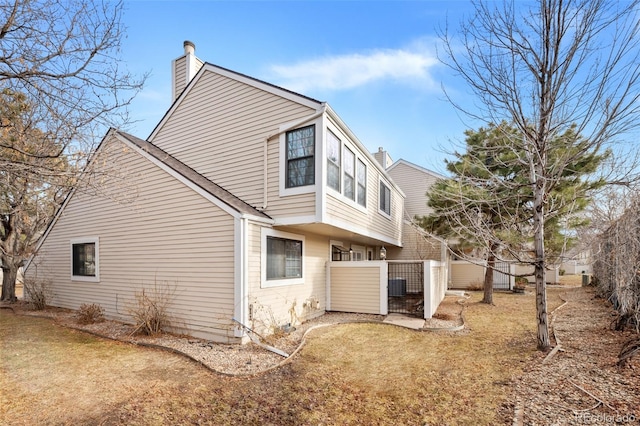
xmin=0 ymin=89 xmax=74 ymax=301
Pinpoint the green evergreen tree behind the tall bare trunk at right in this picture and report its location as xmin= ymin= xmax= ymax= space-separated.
xmin=421 ymin=122 xmax=609 ymax=304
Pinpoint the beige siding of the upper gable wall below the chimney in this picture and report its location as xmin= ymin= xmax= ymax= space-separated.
xmin=152 ymin=70 xmax=315 ymax=215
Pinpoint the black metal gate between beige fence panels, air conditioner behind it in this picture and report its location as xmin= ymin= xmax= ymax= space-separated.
xmin=387 ymin=262 xmax=424 ymax=317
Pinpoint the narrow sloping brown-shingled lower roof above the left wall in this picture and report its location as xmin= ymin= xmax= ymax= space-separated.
xmin=115 ymin=129 xmax=271 ymax=220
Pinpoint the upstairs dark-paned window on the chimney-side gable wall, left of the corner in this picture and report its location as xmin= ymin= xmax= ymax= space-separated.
xmin=286 ymin=125 xmax=316 ymax=188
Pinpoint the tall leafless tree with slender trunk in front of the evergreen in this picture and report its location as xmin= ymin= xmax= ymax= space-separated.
xmin=442 ymin=0 xmax=640 ymax=350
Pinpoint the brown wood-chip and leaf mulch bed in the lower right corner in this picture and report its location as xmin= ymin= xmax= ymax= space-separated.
xmin=505 ymin=287 xmax=640 ymax=425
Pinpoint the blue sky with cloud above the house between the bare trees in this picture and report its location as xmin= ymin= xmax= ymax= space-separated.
xmin=122 ymin=0 xmax=480 ymax=172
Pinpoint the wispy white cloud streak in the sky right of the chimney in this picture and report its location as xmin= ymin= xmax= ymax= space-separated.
xmin=271 ymin=43 xmax=438 ymax=93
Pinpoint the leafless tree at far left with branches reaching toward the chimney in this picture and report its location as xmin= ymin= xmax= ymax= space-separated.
xmin=0 ymin=0 xmax=146 ymax=300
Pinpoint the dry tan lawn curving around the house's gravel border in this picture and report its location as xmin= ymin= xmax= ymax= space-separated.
xmin=0 ymin=289 xmax=562 ymax=425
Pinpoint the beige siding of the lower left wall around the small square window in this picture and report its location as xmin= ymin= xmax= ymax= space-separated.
xmin=27 ymin=140 xmax=240 ymax=342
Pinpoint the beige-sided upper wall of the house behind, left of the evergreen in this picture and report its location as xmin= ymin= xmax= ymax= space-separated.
xmin=387 ymin=160 xmax=438 ymax=219
